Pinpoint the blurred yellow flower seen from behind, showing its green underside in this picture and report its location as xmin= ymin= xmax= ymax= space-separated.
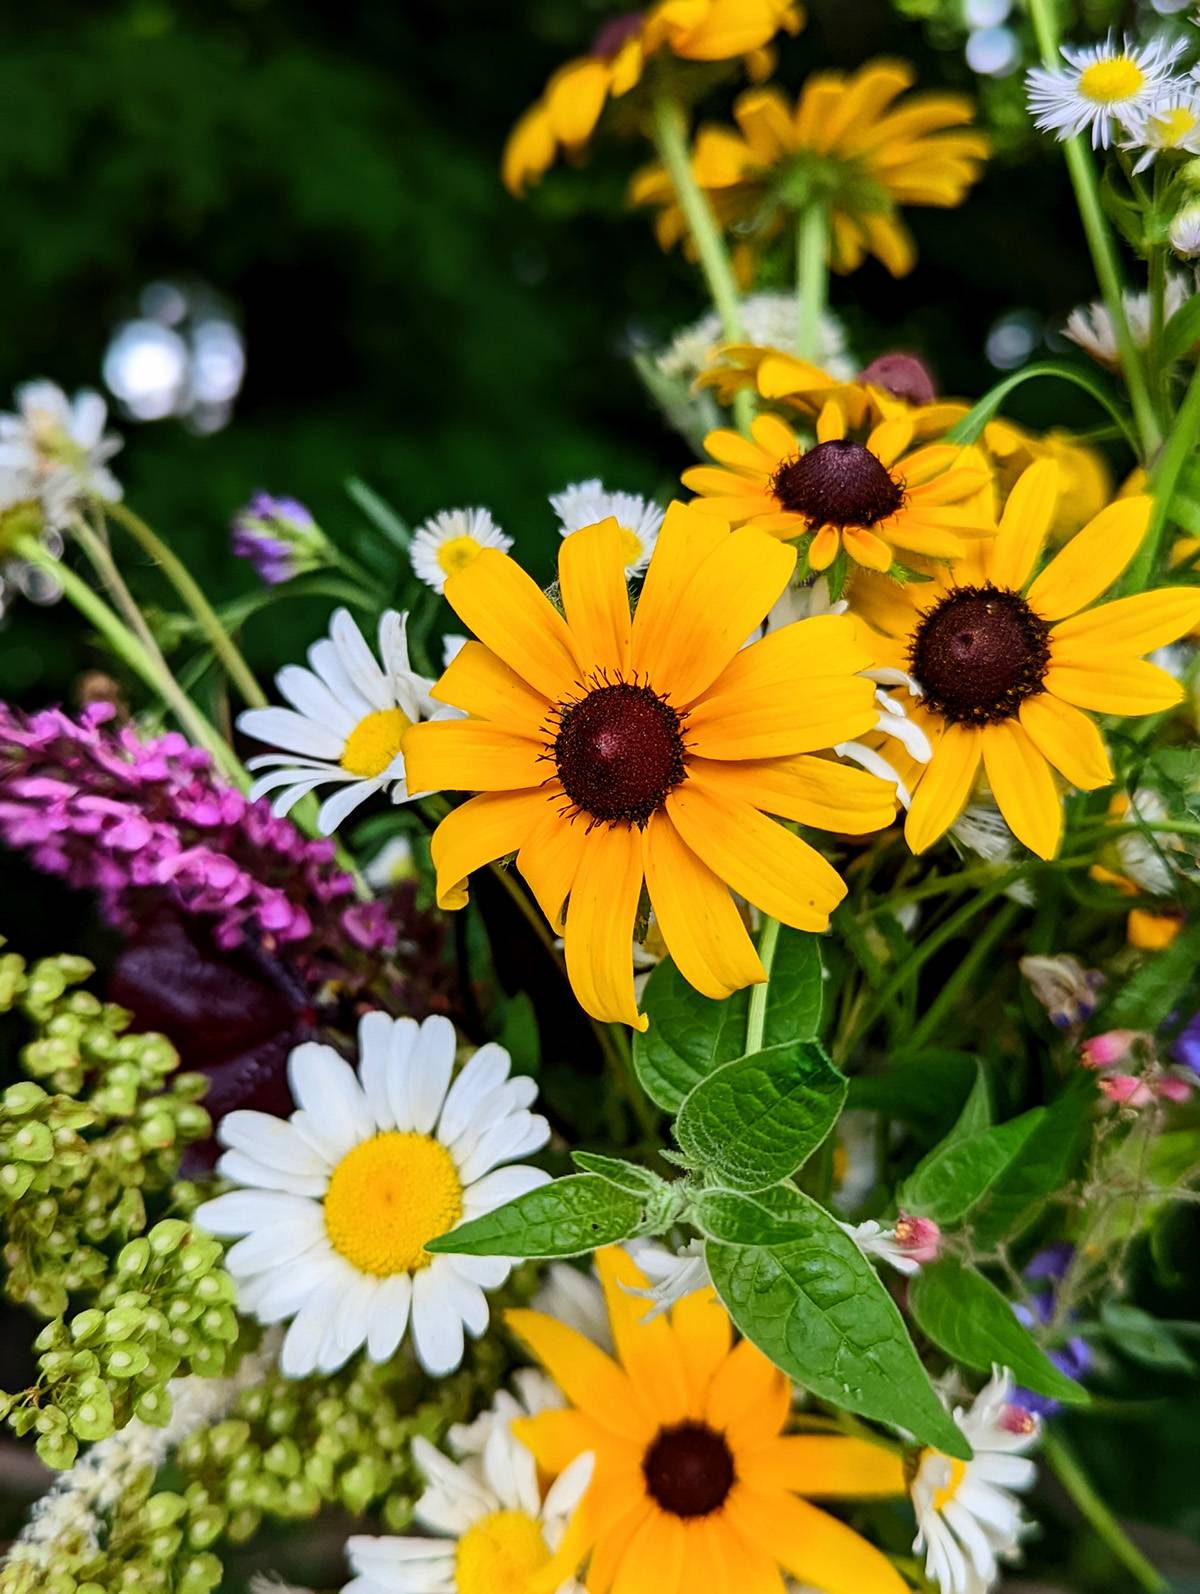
xmin=631 ymin=61 xmax=988 ymax=277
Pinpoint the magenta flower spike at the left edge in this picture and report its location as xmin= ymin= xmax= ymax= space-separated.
xmin=0 ymin=703 xmax=397 ymax=961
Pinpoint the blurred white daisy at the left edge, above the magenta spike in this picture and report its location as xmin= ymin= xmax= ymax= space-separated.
xmin=0 ymin=381 xmax=121 ymax=526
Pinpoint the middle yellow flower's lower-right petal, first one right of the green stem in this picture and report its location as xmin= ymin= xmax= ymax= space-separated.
xmin=666 ymin=779 xmax=846 ymax=929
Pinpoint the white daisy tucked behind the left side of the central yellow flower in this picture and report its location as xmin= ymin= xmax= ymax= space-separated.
xmin=237 ymin=609 xmax=454 ymax=835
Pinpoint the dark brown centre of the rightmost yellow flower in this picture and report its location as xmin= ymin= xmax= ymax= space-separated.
xmin=910 ymin=585 xmax=1050 ymax=725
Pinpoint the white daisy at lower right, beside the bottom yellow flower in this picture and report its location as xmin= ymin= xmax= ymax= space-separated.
xmin=912 ymin=1368 xmax=1041 ymax=1594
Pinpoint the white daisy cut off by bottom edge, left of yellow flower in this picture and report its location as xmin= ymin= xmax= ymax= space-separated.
xmin=343 ymin=1423 xmax=593 ymax=1594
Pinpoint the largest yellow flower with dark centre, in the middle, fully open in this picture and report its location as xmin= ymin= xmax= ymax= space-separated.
xmin=405 ymin=504 xmax=892 ymax=1030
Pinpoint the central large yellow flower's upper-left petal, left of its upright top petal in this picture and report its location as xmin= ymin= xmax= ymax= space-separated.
xmin=446 ymin=548 xmax=582 ymax=703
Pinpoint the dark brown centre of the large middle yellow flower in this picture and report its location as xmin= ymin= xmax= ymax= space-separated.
xmin=551 ymin=681 xmax=687 ymax=826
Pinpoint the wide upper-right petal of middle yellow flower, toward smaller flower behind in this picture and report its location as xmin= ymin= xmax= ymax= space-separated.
xmin=633 ymin=515 xmax=795 ymax=709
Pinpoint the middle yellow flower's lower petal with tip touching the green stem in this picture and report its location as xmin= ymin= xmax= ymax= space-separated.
xmin=645 ymin=813 xmax=767 ymax=1001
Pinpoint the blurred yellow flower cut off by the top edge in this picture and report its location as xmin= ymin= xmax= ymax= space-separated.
xmin=502 ymin=0 xmax=803 ymax=196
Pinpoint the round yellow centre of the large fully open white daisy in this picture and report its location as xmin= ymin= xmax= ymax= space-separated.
xmin=325 ymin=1130 xmax=462 ymax=1278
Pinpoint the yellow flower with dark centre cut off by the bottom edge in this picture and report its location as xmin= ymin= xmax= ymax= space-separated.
xmin=508 ymin=1250 xmax=907 ymax=1594
